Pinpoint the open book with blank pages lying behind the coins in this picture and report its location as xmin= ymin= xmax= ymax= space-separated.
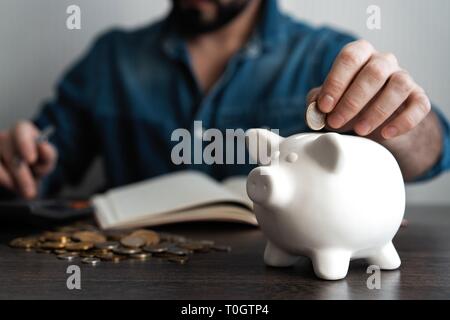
xmin=92 ymin=171 xmax=257 ymax=229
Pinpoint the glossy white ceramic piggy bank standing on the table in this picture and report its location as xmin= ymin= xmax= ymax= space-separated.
xmin=247 ymin=129 xmax=405 ymax=280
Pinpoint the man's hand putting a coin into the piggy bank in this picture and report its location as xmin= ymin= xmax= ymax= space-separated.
xmin=308 ymin=40 xmax=431 ymax=141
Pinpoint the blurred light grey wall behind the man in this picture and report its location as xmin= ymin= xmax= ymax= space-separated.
xmin=0 ymin=0 xmax=450 ymax=204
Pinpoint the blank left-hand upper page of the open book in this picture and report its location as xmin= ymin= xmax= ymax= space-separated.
xmin=96 ymin=171 xmax=247 ymax=223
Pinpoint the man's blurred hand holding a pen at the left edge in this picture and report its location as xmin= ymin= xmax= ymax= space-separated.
xmin=0 ymin=121 xmax=57 ymax=198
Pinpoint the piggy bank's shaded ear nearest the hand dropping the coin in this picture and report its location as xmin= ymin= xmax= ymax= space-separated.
xmin=306 ymin=133 xmax=343 ymax=172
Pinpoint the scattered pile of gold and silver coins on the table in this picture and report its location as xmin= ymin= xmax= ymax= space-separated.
xmin=10 ymin=223 xmax=231 ymax=266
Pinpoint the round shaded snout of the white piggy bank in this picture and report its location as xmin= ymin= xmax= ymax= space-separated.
xmin=247 ymin=168 xmax=274 ymax=203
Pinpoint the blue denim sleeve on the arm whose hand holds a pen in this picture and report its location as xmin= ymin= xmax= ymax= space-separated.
xmin=33 ymin=31 xmax=115 ymax=196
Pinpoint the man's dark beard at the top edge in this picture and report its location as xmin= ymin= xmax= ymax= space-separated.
xmin=171 ymin=0 xmax=251 ymax=36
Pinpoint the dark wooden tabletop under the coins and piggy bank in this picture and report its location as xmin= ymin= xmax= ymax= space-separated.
xmin=0 ymin=207 xmax=450 ymax=299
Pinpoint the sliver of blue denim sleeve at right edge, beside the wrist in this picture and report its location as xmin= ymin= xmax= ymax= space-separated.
xmin=413 ymin=106 xmax=450 ymax=183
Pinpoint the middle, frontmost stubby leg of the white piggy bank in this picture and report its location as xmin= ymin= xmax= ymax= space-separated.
xmin=311 ymin=250 xmax=350 ymax=280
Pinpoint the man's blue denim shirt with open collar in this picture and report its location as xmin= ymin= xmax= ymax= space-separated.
xmin=35 ymin=0 xmax=450 ymax=195
